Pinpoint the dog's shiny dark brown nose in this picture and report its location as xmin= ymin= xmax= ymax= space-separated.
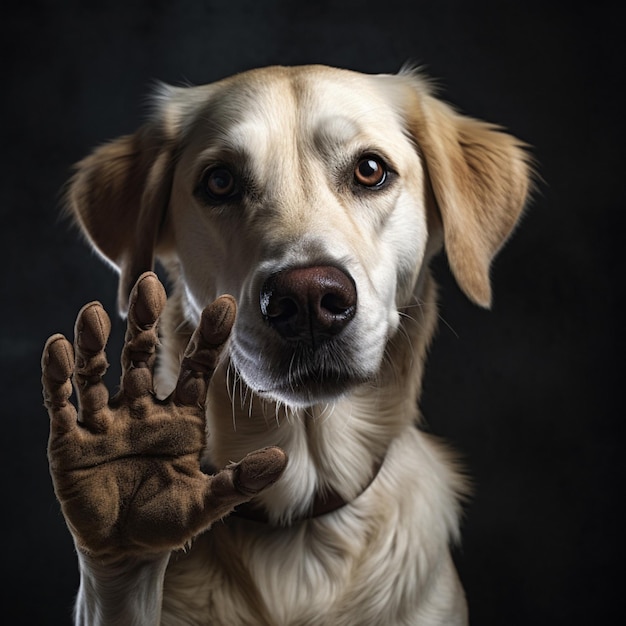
xmin=261 ymin=266 xmax=357 ymax=347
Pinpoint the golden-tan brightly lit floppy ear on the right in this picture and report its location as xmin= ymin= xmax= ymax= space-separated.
xmin=408 ymin=78 xmax=530 ymax=308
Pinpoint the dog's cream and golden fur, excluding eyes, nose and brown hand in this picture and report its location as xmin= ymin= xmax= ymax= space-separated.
xmin=70 ymin=66 xmax=529 ymax=626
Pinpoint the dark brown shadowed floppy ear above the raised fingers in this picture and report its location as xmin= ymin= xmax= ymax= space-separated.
xmin=68 ymin=122 xmax=174 ymax=314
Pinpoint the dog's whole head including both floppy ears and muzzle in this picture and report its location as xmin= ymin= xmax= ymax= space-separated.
xmin=70 ymin=66 xmax=529 ymax=406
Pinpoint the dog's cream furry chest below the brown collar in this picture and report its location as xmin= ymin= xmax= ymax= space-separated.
xmin=158 ymin=429 xmax=466 ymax=626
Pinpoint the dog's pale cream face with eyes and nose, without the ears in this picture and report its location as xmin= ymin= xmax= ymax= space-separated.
xmin=170 ymin=70 xmax=428 ymax=405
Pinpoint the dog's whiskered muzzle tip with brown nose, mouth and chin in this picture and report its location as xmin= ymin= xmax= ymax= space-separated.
xmin=230 ymin=264 xmax=370 ymax=407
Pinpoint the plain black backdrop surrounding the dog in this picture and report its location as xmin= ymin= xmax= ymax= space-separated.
xmin=0 ymin=0 xmax=626 ymax=626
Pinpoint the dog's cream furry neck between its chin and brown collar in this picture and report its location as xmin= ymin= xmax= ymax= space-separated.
xmin=160 ymin=275 xmax=437 ymax=524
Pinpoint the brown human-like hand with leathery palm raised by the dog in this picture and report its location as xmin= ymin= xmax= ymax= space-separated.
xmin=42 ymin=273 xmax=287 ymax=557
